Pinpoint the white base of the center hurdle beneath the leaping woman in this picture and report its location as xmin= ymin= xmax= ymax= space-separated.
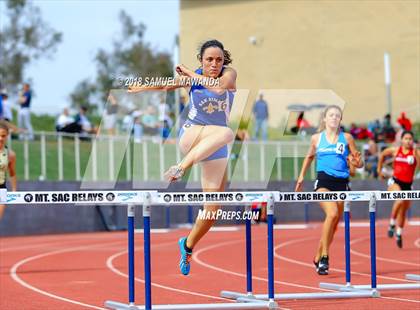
xmin=105 ymin=298 xmax=278 ymax=310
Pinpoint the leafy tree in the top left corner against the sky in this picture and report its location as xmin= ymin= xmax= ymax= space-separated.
xmin=0 ymin=0 xmax=62 ymax=91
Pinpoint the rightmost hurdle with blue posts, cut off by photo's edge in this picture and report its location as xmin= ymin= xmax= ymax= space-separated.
xmin=319 ymin=191 xmax=420 ymax=292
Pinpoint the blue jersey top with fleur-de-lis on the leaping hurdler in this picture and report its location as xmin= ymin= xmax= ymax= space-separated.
xmin=188 ymin=68 xmax=234 ymax=126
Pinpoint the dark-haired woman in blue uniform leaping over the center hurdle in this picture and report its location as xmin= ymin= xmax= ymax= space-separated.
xmin=129 ymin=40 xmax=237 ymax=275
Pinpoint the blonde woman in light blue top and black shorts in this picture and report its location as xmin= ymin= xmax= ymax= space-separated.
xmin=295 ymin=105 xmax=363 ymax=275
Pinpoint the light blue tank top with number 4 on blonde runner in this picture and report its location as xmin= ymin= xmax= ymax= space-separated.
xmin=316 ymin=131 xmax=350 ymax=179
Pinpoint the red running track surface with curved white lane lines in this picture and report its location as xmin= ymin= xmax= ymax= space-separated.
xmin=0 ymin=219 xmax=420 ymax=310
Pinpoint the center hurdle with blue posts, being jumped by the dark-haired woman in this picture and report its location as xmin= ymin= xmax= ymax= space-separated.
xmin=105 ymin=192 xmax=280 ymax=310
